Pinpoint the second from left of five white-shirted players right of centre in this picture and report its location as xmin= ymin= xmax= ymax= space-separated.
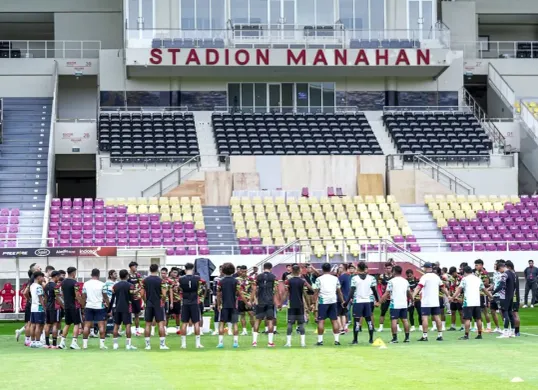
xmin=345 ymin=261 xmax=379 ymax=344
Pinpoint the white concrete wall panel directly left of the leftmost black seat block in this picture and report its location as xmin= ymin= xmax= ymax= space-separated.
xmin=54 ymin=122 xmax=97 ymax=154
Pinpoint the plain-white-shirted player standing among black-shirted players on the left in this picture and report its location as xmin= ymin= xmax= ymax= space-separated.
xmin=82 ymin=268 xmax=110 ymax=349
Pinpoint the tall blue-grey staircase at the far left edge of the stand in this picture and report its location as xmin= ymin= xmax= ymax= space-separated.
xmin=0 ymin=98 xmax=52 ymax=246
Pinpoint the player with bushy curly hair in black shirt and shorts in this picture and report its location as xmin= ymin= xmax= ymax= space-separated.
xmin=217 ymin=263 xmax=247 ymax=348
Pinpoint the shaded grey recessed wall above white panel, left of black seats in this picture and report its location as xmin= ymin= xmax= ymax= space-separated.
xmin=57 ymin=76 xmax=98 ymax=119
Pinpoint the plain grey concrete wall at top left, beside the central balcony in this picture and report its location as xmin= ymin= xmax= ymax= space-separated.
xmin=54 ymin=11 xmax=124 ymax=49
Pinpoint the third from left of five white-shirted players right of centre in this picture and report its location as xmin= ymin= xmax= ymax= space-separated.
xmin=381 ymin=265 xmax=413 ymax=344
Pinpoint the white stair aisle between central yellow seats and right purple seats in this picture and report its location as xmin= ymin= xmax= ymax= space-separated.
xmin=400 ymin=205 xmax=450 ymax=252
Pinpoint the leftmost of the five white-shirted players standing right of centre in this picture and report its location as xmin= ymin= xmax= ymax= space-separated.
xmin=312 ymin=263 xmax=344 ymax=345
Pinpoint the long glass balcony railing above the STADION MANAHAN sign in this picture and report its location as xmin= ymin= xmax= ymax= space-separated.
xmin=125 ymin=24 xmax=450 ymax=49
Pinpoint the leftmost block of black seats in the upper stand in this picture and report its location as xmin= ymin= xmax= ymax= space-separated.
xmin=99 ymin=112 xmax=200 ymax=162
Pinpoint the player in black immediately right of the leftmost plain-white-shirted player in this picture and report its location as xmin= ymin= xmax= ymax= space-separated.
xmin=110 ymin=269 xmax=136 ymax=350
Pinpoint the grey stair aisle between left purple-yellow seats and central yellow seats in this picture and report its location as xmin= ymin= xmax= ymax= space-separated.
xmin=202 ymin=206 xmax=239 ymax=255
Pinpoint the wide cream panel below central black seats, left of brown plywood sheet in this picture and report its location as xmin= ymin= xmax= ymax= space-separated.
xmin=281 ymin=156 xmax=357 ymax=195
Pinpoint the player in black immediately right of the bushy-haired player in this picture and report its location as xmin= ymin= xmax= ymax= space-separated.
xmin=251 ymin=263 xmax=278 ymax=347
